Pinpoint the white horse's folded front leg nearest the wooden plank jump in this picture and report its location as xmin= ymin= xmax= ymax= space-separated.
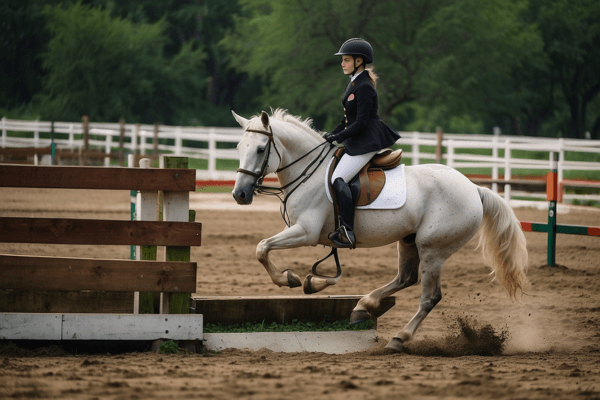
xmin=256 ymin=224 xmax=318 ymax=288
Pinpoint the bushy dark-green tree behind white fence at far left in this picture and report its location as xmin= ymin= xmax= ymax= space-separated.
xmin=36 ymin=3 xmax=206 ymax=123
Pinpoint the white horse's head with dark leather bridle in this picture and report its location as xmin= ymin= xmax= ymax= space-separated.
xmin=232 ymin=111 xmax=281 ymax=204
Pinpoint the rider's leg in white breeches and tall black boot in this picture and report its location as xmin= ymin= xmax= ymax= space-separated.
xmin=329 ymin=151 xmax=377 ymax=248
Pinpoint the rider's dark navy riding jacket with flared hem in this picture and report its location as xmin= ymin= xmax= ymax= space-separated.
xmin=331 ymin=71 xmax=400 ymax=156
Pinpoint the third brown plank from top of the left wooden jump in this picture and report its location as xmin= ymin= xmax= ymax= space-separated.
xmin=0 ymin=254 xmax=197 ymax=293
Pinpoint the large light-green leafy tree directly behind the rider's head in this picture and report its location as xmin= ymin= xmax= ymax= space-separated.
xmin=222 ymin=0 xmax=542 ymax=130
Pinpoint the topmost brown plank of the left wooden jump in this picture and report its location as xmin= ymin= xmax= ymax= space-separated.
xmin=0 ymin=165 xmax=196 ymax=192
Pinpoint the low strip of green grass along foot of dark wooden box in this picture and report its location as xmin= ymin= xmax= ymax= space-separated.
xmin=204 ymin=319 xmax=375 ymax=333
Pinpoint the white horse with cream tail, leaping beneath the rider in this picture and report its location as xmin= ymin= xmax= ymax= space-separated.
xmin=233 ymin=109 xmax=528 ymax=351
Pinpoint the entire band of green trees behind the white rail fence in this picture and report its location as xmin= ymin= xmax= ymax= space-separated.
xmin=0 ymin=0 xmax=600 ymax=139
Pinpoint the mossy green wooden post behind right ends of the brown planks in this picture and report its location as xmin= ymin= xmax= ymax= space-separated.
xmin=161 ymin=157 xmax=196 ymax=314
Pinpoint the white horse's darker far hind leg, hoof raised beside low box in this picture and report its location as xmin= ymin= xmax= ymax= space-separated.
xmin=350 ymin=242 xmax=419 ymax=324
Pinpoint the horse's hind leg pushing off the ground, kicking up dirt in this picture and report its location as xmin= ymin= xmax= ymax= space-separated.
xmin=385 ymin=253 xmax=446 ymax=352
